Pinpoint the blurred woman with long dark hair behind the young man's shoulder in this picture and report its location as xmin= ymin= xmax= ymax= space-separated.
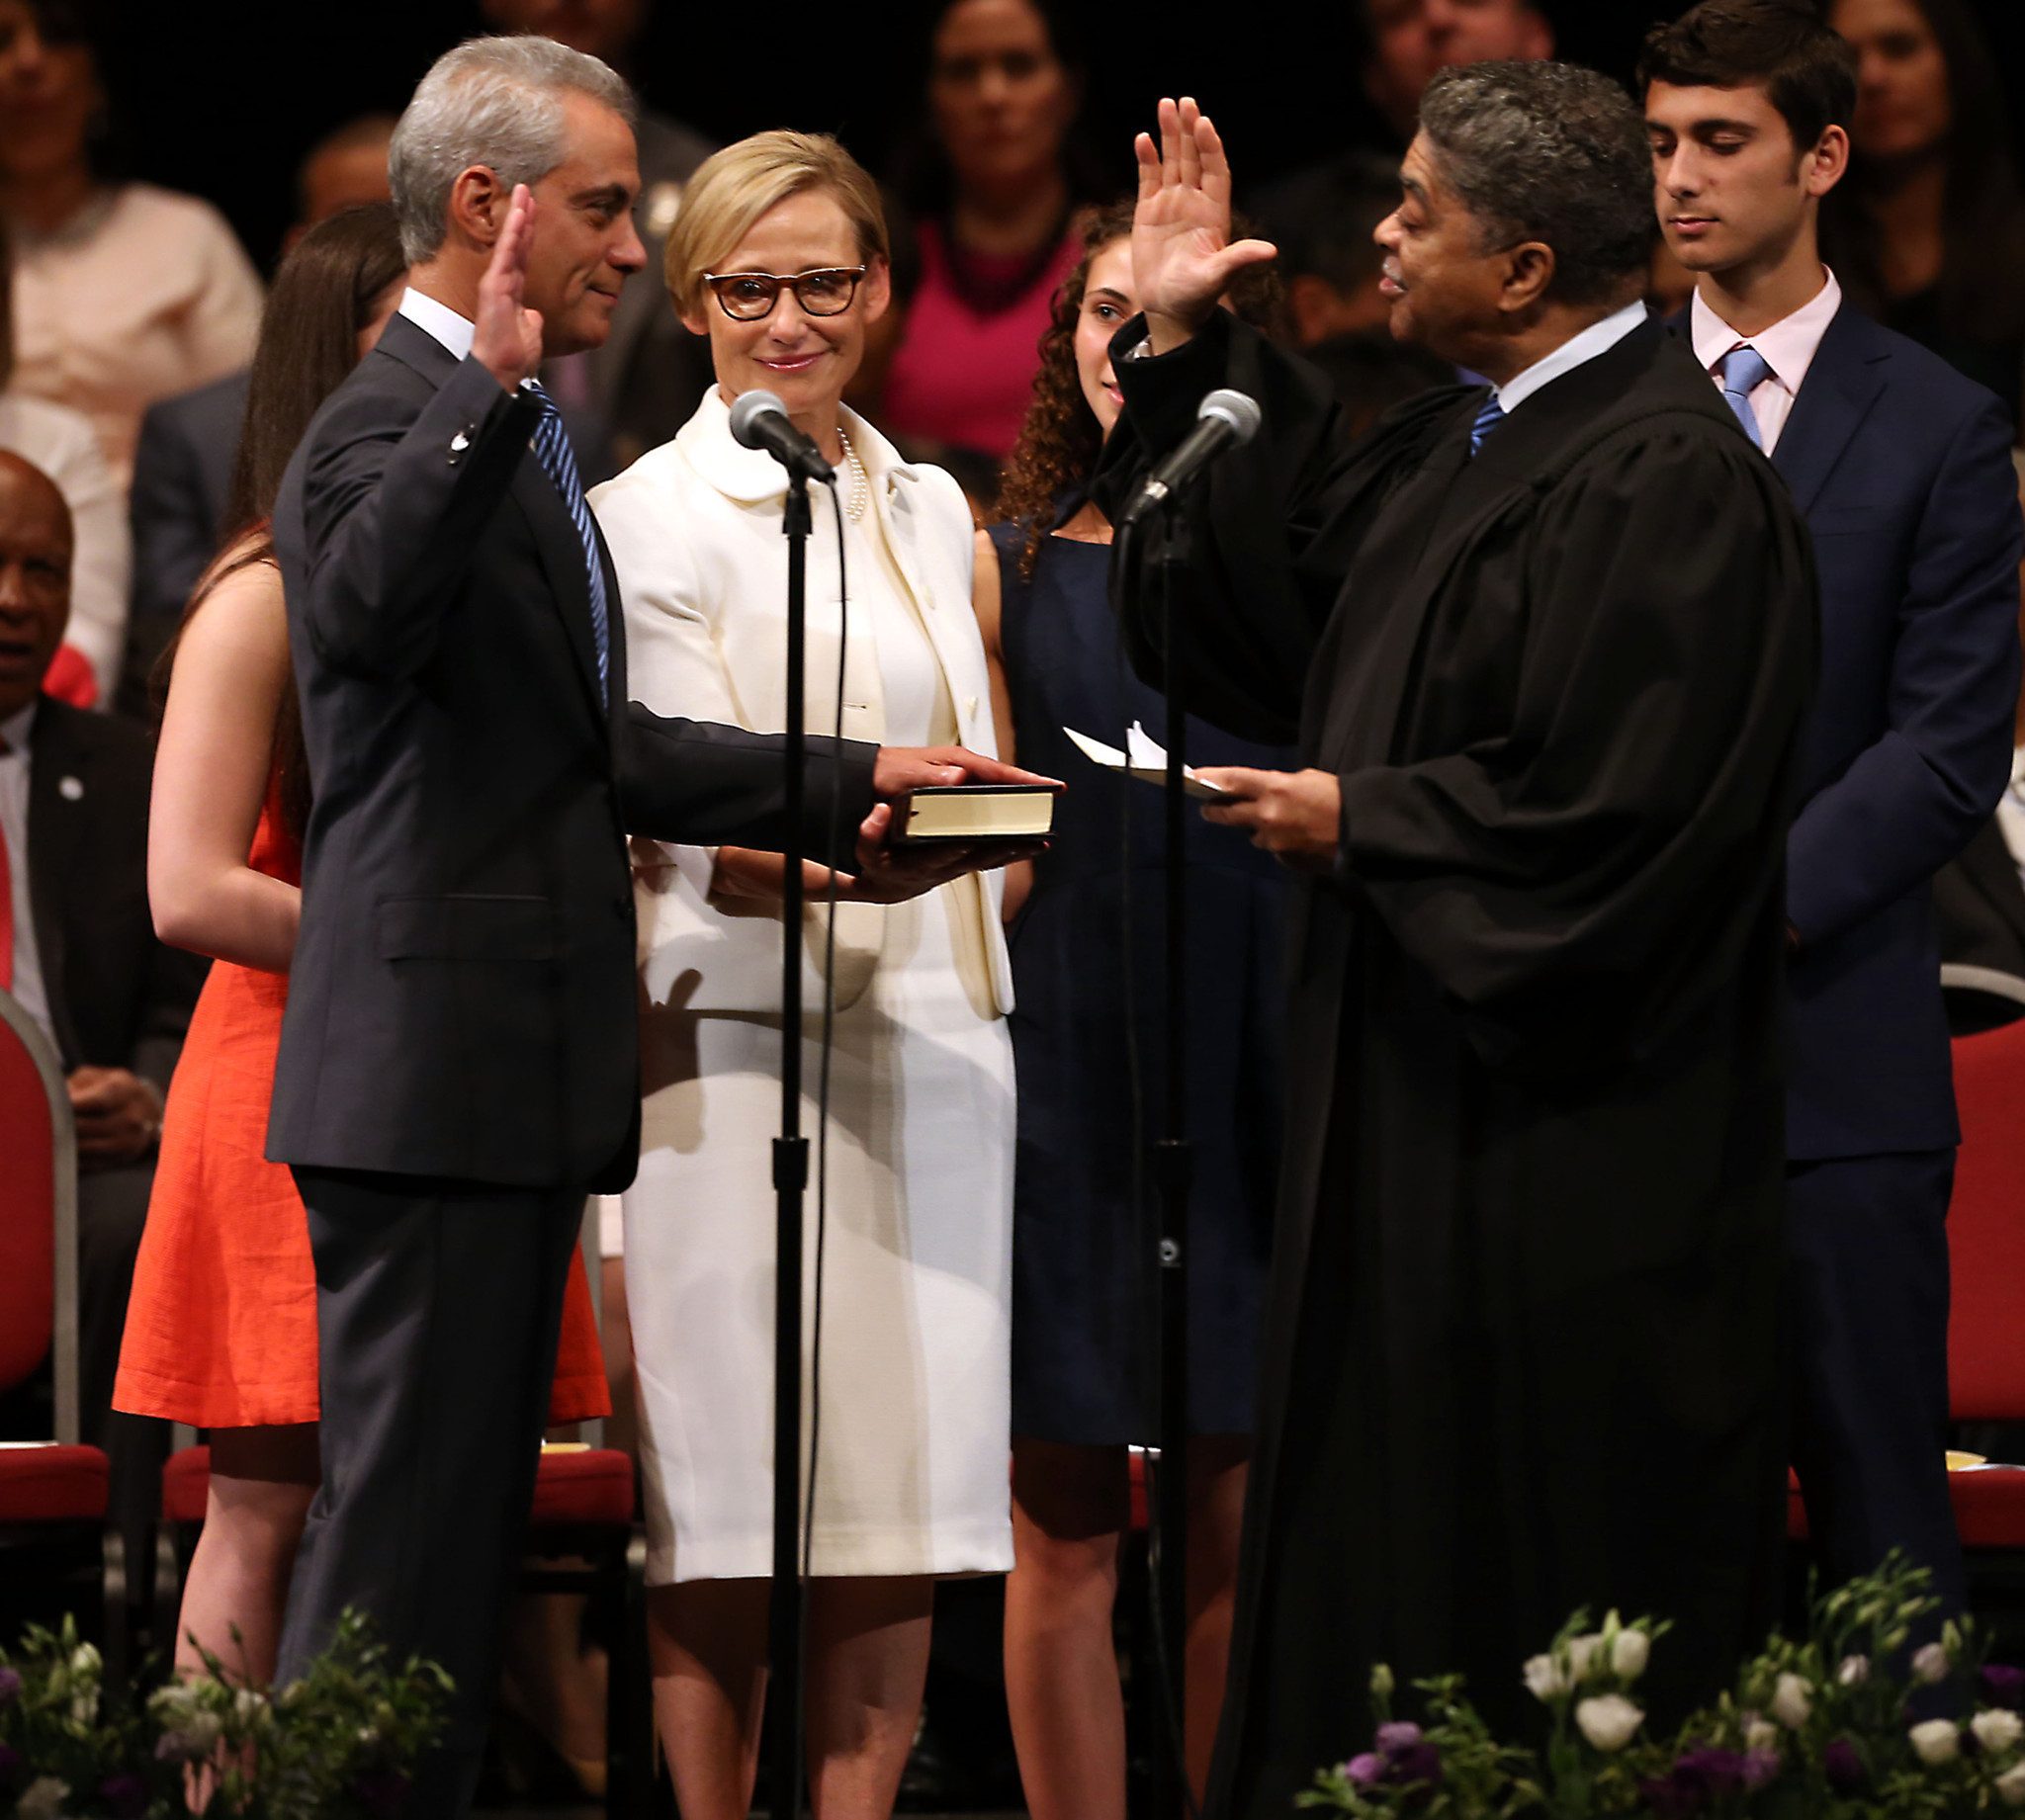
xmin=1822 ymin=0 xmax=2025 ymax=425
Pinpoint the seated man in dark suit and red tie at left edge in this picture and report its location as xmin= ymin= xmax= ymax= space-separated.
xmin=0 ymin=454 xmax=205 ymax=1534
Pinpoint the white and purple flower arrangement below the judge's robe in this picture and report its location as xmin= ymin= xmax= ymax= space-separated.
xmin=1298 ymin=1555 xmax=2025 ymax=1820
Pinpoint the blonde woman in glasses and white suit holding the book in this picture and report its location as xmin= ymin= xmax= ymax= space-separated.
xmin=591 ymin=131 xmax=1012 ymax=1820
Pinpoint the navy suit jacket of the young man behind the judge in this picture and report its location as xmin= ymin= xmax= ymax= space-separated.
xmin=1677 ymin=303 xmax=2025 ymax=1162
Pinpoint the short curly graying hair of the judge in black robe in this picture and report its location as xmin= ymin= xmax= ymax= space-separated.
xmin=1420 ymin=62 xmax=1654 ymax=303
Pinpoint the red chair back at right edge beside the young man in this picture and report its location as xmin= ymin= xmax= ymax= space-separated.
xmin=1948 ymin=1022 xmax=2025 ymax=1422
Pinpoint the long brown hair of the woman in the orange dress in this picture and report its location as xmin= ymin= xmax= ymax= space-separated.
xmin=148 ymin=203 xmax=407 ymax=840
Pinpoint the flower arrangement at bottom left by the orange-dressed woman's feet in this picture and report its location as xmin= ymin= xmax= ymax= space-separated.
xmin=0 ymin=1611 xmax=450 ymax=1820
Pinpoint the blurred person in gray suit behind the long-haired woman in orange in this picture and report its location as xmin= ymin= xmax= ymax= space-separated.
xmin=117 ymin=112 xmax=393 ymax=721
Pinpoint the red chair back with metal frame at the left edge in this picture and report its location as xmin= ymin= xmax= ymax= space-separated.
xmin=0 ymin=992 xmax=77 ymax=1441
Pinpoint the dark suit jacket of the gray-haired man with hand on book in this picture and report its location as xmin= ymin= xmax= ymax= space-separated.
xmin=267 ymin=315 xmax=875 ymax=1190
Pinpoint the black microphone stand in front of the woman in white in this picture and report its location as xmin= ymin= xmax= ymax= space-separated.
xmin=767 ymin=466 xmax=812 ymax=1820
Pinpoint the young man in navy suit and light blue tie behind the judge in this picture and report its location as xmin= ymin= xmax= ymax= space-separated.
xmin=1640 ymin=0 xmax=2019 ymax=1609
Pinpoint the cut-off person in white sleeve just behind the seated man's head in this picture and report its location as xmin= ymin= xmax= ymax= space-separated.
xmin=0 ymin=222 xmax=128 ymax=709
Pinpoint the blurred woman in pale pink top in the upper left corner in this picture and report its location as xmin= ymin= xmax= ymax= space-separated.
xmin=0 ymin=0 xmax=261 ymax=490
